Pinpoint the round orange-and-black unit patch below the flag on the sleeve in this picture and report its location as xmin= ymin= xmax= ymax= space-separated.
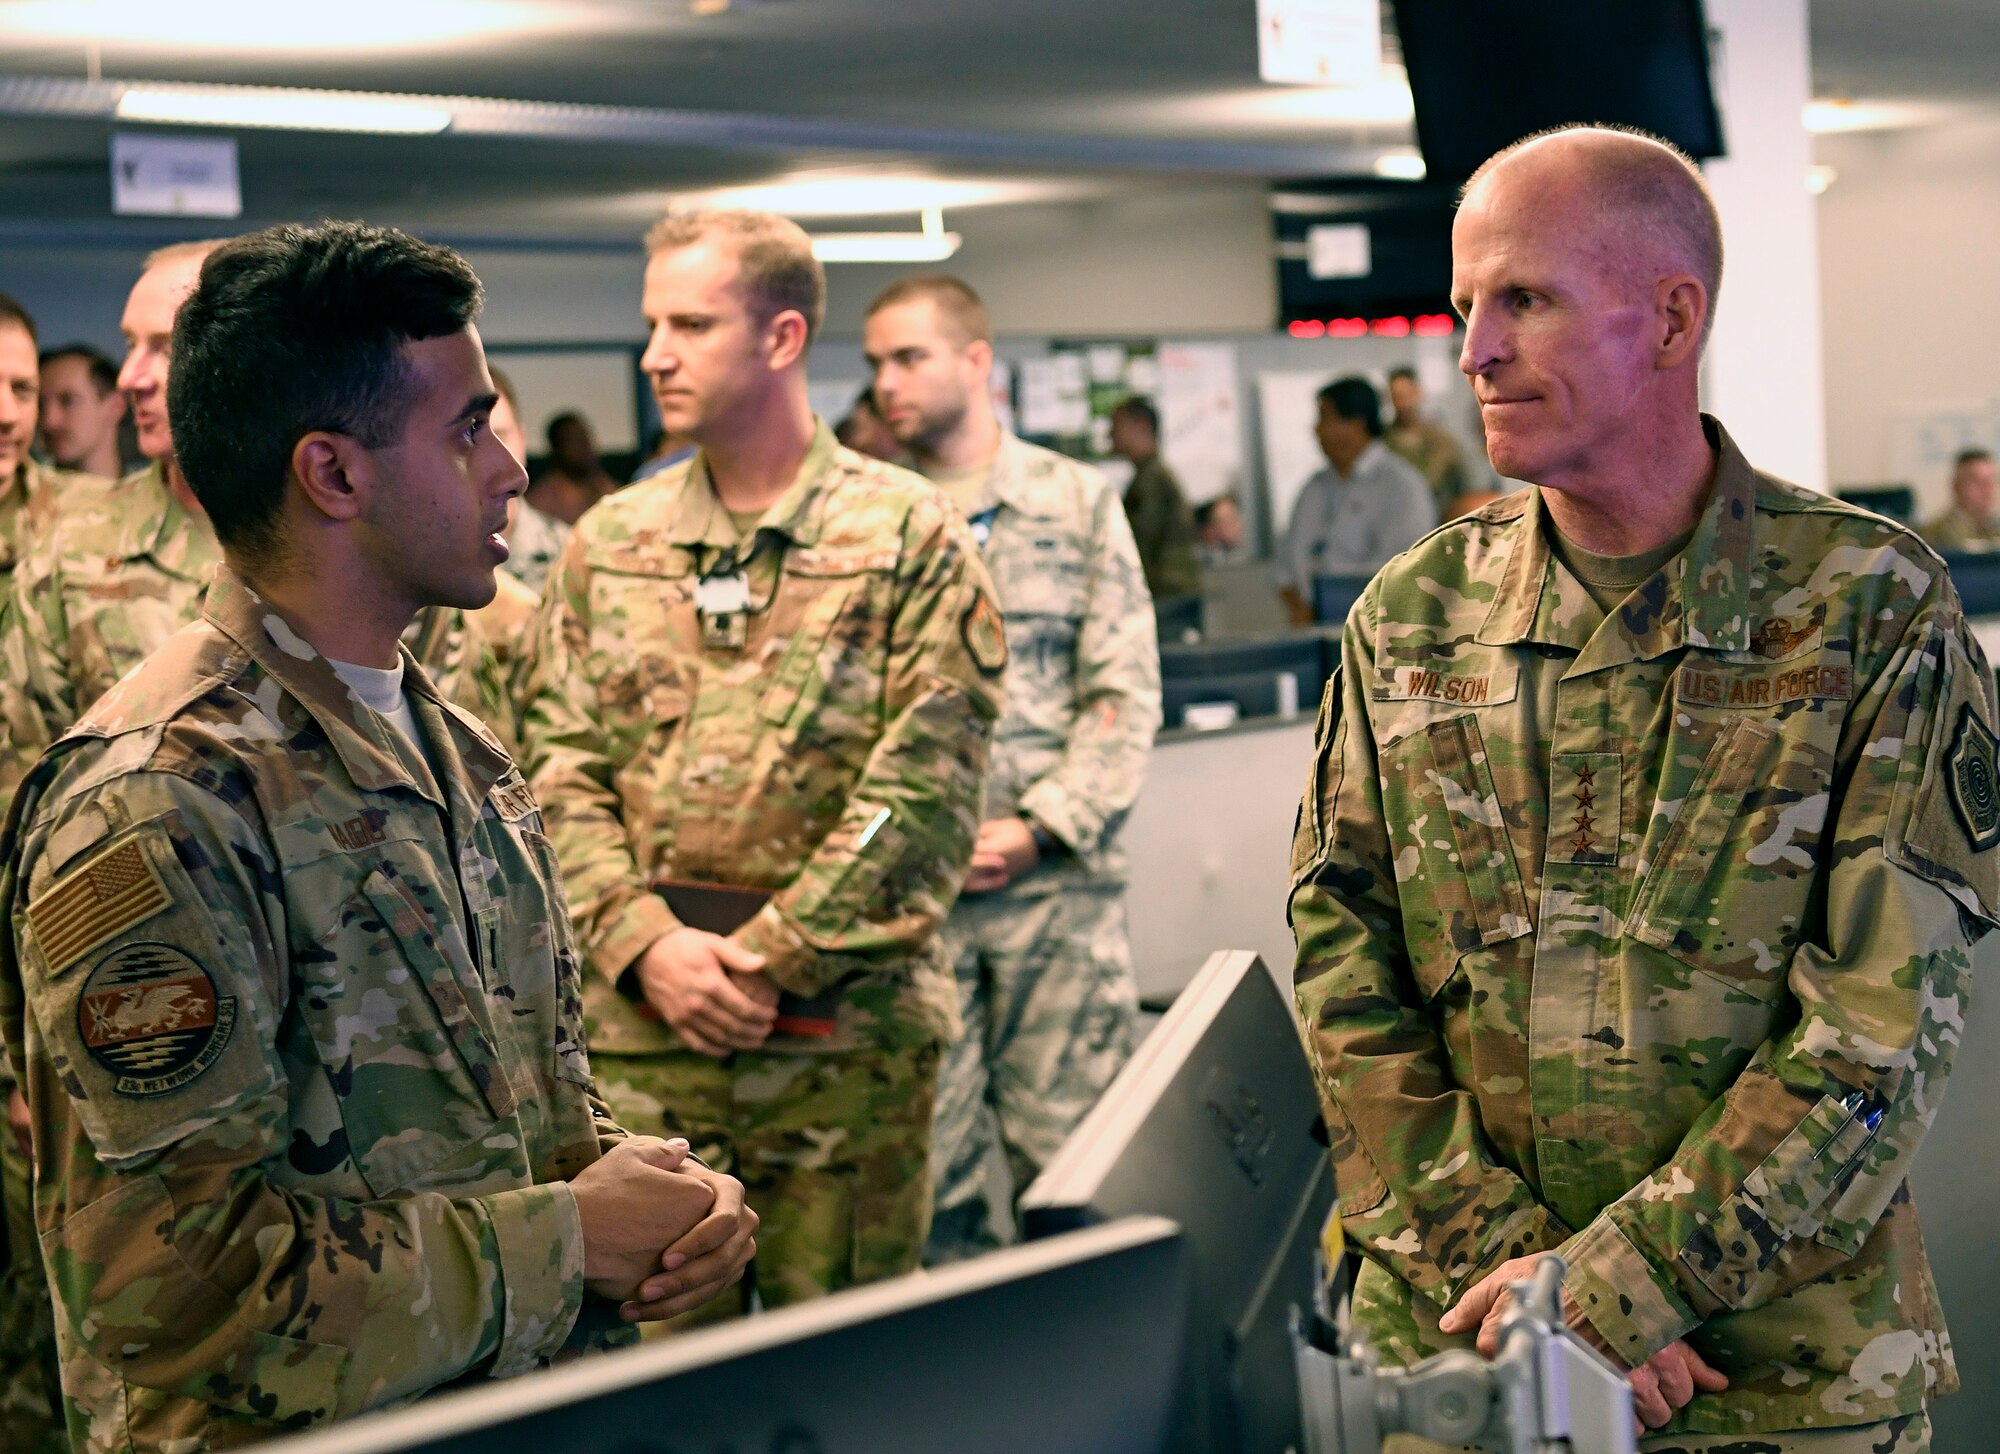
xmin=76 ymin=942 xmax=236 ymax=1096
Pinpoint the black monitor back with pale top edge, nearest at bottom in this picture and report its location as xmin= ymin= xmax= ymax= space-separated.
xmin=282 ymin=1218 xmax=1188 ymax=1454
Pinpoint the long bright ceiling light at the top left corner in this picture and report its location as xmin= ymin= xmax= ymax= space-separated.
xmin=0 ymin=0 xmax=578 ymax=52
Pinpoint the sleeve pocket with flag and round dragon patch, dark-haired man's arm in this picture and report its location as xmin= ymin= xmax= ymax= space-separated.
xmin=22 ymin=820 xmax=278 ymax=1168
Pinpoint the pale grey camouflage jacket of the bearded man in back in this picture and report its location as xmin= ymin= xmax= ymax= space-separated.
xmin=966 ymin=436 xmax=1160 ymax=894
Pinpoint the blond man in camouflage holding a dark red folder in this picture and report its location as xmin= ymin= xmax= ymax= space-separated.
xmin=524 ymin=212 xmax=1006 ymax=1304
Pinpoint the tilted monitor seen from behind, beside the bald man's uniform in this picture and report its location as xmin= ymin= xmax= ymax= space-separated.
xmin=1020 ymin=950 xmax=1334 ymax=1454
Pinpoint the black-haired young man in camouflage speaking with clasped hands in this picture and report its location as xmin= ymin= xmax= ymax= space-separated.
xmin=0 ymin=224 xmax=754 ymax=1454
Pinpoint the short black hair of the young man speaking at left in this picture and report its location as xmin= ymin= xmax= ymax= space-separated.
xmin=166 ymin=222 xmax=484 ymax=558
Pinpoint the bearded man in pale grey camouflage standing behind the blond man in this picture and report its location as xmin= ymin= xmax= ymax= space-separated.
xmin=864 ymin=276 xmax=1160 ymax=1262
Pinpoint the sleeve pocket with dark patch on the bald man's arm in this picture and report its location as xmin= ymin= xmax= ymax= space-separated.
xmin=1882 ymin=636 xmax=2000 ymax=928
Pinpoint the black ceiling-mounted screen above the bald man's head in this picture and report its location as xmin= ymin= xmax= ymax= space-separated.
xmin=1392 ymin=0 xmax=1724 ymax=182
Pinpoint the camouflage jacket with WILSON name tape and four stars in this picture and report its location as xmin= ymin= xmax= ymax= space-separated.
xmin=1290 ymin=420 xmax=2000 ymax=1434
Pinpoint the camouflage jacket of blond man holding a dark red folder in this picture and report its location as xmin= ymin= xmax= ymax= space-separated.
xmin=524 ymin=426 xmax=1008 ymax=1054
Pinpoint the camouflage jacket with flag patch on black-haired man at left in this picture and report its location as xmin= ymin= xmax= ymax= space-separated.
xmin=0 ymin=570 xmax=624 ymax=1454
